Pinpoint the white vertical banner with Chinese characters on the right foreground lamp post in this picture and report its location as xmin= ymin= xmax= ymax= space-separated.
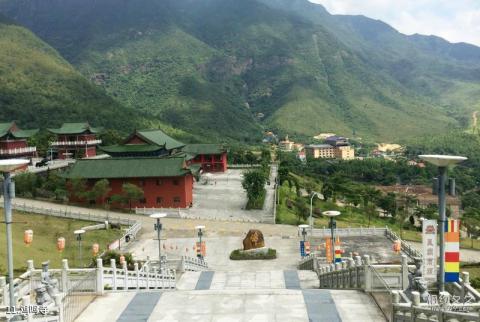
xmin=422 ymin=220 xmax=438 ymax=281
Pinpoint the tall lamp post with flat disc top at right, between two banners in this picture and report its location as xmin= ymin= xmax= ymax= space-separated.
xmin=419 ymin=155 xmax=467 ymax=292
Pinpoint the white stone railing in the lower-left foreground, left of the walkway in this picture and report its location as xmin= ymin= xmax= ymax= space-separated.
xmin=0 ymin=258 xmax=176 ymax=322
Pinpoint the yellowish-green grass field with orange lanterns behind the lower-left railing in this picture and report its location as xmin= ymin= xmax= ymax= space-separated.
xmin=0 ymin=212 xmax=122 ymax=275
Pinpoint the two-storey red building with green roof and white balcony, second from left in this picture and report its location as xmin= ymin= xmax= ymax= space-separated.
xmin=48 ymin=123 xmax=102 ymax=159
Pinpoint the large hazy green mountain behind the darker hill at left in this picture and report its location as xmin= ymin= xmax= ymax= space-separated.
xmin=0 ymin=0 xmax=480 ymax=141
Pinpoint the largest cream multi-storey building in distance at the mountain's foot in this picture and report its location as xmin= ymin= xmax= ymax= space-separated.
xmin=305 ymin=136 xmax=355 ymax=160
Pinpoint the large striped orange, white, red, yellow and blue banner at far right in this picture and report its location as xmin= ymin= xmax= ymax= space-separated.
xmin=445 ymin=219 xmax=460 ymax=283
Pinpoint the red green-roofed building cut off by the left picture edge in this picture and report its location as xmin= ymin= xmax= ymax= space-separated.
xmin=0 ymin=122 xmax=38 ymax=159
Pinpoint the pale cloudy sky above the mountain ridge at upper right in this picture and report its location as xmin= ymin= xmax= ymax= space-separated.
xmin=310 ymin=0 xmax=480 ymax=46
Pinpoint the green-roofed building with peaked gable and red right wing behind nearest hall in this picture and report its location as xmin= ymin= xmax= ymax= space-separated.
xmin=99 ymin=130 xmax=227 ymax=172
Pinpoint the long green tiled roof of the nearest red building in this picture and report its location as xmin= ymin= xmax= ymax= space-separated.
xmin=65 ymin=158 xmax=191 ymax=179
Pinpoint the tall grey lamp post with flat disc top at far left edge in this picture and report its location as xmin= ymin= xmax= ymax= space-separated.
xmin=0 ymin=159 xmax=29 ymax=306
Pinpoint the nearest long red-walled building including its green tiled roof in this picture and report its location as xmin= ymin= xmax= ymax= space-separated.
xmin=66 ymin=157 xmax=193 ymax=208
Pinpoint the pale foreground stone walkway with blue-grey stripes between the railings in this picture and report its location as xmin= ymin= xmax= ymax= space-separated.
xmin=77 ymin=271 xmax=385 ymax=322
